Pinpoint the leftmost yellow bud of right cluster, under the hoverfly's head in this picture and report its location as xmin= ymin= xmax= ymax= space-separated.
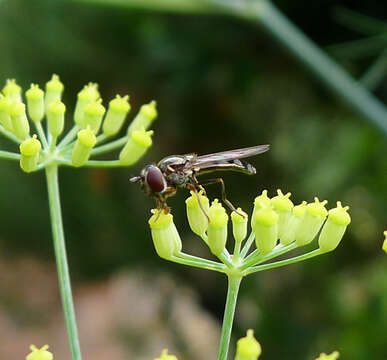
xmin=148 ymin=209 xmax=182 ymax=260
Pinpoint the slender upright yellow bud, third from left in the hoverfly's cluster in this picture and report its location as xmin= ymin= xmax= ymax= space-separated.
xmin=207 ymin=199 xmax=228 ymax=256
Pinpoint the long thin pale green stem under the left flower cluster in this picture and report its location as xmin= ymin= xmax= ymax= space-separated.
xmin=46 ymin=164 xmax=82 ymax=360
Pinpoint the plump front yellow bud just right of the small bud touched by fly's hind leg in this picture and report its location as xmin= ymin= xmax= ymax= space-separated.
xmin=252 ymin=208 xmax=279 ymax=255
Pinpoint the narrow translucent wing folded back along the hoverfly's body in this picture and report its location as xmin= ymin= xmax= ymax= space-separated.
xmin=192 ymin=145 xmax=270 ymax=167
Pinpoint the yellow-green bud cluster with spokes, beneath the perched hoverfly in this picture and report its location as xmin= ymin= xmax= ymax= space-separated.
xmin=149 ymin=190 xmax=351 ymax=275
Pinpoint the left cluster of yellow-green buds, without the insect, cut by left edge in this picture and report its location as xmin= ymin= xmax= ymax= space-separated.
xmin=0 ymin=75 xmax=157 ymax=173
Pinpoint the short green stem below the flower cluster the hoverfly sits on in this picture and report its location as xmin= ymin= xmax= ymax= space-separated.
xmin=218 ymin=275 xmax=242 ymax=360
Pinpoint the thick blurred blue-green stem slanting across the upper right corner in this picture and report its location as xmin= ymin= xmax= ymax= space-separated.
xmin=229 ymin=0 xmax=387 ymax=134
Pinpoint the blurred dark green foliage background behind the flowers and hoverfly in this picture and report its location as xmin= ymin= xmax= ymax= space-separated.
xmin=0 ymin=0 xmax=387 ymax=360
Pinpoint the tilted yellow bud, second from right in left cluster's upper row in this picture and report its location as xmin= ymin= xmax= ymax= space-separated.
xmin=103 ymin=95 xmax=130 ymax=136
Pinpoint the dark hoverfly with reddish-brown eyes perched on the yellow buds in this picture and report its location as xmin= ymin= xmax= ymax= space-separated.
xmin=130 ymin=145 xmax=269 ymax=218
